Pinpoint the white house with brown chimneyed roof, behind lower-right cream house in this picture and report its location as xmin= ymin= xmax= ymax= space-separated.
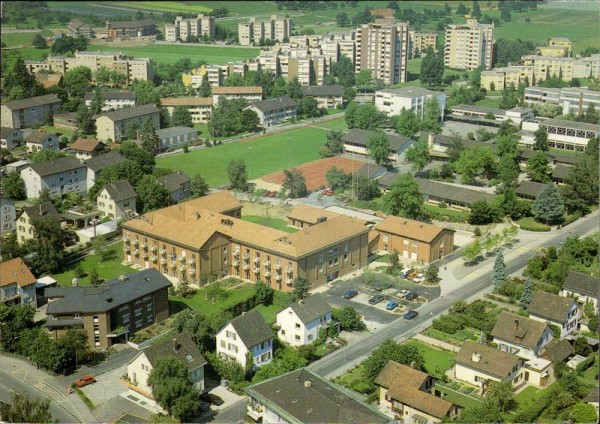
xmin=490 ymin=312 xmax=554 ymax=360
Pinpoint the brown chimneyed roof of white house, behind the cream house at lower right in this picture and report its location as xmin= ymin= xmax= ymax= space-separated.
xmin=490 ymin=312 xmax=548 ymax=349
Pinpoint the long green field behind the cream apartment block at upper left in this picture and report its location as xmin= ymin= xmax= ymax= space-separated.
xmin=88 ymin=44 xmax=259 ymax=65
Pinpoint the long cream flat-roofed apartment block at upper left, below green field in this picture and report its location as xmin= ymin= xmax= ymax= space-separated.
xmin=25 ymin=51 xmax=153 ymax=84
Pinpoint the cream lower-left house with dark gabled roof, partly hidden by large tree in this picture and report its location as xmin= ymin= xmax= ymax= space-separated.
xmin=127 ymin=332 xmax=208 ymax=402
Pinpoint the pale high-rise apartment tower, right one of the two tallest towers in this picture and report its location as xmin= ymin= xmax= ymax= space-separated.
xmin=444 ymin=19 xmax=494 ymax=71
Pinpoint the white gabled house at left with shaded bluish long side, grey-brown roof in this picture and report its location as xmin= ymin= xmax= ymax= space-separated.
xmin=21 ymin=156 xmax=88 ymax=199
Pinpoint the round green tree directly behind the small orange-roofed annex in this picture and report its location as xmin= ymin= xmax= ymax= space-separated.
xmin=383 ymin=174 xmax=425 ymax=219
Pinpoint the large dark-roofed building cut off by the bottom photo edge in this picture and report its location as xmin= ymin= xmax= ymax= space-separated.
xmin=244 ymin=368 xmax=390 ymax=424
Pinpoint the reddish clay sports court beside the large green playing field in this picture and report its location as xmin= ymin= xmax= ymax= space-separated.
xmin=262 ymin=156 xmax=364 ymax=191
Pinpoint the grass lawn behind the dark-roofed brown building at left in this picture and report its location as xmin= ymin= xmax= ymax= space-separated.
xmin=52 ymin=241 xmax=135 ymax=286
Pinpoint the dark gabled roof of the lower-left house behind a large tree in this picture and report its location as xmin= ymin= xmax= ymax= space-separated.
xmin=141 ymin=333 xmax=208 ymax=372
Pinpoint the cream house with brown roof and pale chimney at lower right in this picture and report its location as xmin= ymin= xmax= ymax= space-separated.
xmin=454 ymin=340 xmax=525 ymax=394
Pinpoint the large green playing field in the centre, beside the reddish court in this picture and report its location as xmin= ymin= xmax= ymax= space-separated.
xmin=157 ymin=124 xmax=342 ymax=187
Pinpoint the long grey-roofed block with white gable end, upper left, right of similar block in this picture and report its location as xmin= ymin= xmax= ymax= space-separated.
xmin=96 ymin=104 xmax=160 ymax=142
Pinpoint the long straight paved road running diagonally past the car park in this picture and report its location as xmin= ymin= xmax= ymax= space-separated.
xmin=308 ymin=211 xmax=599 ymax=378
